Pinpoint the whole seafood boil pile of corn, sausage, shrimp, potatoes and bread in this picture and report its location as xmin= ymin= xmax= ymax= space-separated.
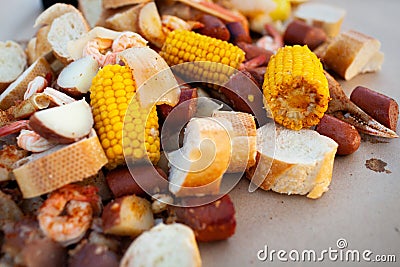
xmin=0 ymin=0 xmax=399 ymax=267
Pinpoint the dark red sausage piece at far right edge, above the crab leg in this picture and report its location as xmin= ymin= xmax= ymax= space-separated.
xmin=350 ymin=86 xmax=399 ymax=131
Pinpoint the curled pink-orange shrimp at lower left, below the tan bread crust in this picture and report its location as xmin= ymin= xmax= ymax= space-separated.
xmin=38 ymin=184 xmax=101 ymax=247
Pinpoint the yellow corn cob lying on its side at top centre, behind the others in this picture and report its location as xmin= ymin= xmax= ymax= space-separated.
xmin=160 ymin=30 xmax=245 ymax=83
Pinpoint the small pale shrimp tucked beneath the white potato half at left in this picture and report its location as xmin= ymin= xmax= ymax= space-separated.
xmin=17 ymin=129 xmax=56 ymax=152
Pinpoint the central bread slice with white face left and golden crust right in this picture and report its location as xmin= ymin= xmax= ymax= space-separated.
xmin=168 ymin=118 xmax=232 ymax=196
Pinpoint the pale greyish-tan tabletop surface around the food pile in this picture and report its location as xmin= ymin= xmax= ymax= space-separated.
xmin=0 ymin=0 xmax=400 ymax=267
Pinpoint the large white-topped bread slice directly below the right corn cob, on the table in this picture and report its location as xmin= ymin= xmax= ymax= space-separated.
xmin=246 ymin=123 xmax=338 ymax=199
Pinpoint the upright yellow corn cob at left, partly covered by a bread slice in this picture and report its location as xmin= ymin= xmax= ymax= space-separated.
xmin=90 ymin=65 xmax=160 ymax=169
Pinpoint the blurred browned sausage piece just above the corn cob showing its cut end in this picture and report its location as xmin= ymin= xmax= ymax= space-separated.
xmin=283 ymin=20 xmax=327 ymax=50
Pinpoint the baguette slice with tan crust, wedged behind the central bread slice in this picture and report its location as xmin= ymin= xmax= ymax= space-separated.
xmin=213 ymin=110 xmax=257 ymax=172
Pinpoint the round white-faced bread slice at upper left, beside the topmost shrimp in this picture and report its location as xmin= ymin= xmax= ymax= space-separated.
xmin=47 ymin=11 xmax=90 ymax=64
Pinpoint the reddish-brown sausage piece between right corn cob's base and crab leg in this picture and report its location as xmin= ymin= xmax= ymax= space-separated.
xmin=316 ymin=114 xmax=361 ymax=155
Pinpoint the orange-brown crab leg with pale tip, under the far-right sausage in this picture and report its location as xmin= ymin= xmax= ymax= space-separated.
xmin=325 ymin=72 xmax=399 ymax=138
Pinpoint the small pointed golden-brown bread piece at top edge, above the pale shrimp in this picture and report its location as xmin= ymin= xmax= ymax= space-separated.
xmin=105 ymin=4 xmax=144 ymax=32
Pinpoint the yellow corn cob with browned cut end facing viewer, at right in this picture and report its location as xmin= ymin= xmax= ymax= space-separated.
xmin=263 ymin=45 xmax=330 ymax=130
